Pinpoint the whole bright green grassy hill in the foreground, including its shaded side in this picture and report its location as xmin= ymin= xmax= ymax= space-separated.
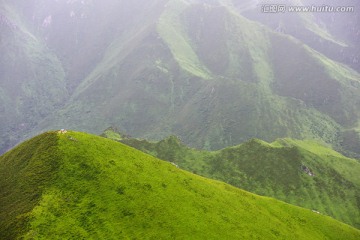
xmin=0 ymin=131 xmax=360 ymax=239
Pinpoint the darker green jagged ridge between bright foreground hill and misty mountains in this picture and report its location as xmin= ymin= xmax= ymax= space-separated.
xmin=104 ymin=129 xmax=360 ymax=228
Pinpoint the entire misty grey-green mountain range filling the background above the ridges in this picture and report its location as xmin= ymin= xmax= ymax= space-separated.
xmin=0 ymin=0 xmax=360 ymax=157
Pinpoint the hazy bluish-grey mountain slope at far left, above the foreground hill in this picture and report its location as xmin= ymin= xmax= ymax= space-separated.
xmin=0 ymin=1 xmax=69 ymax=153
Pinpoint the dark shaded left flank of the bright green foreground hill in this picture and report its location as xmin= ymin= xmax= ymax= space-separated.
xmin=0 ymin=133 xmax=60 ymax=239
